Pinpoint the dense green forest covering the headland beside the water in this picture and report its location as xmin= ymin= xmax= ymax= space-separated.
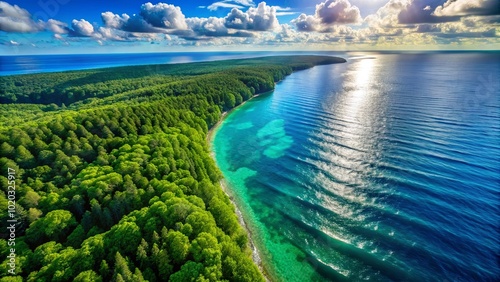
xmin=0 ymin=56 xmax=345 ymax=282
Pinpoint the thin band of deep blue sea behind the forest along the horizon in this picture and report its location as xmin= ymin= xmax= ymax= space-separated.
xmin=0 ymin=50 xmax=500 ymax=77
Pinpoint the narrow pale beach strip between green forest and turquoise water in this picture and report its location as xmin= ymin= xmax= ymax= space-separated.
xmin=206 ymin=91 xmax=277 ymax=282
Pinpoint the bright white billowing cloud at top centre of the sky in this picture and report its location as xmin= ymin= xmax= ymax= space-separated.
xmin=224 ymin=2 xmax=279 ymax=31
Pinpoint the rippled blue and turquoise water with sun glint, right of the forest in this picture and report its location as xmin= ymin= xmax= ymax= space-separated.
xmin=212 ymin=53 xmax=500 ymax=281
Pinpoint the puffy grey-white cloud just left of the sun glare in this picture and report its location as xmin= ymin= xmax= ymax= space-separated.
xmin=292 ymin=0 xmax=362 ymax=31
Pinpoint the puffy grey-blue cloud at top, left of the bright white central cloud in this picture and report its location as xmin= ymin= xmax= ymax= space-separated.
xmin=140 ymin=2 xmax=187 ymax=29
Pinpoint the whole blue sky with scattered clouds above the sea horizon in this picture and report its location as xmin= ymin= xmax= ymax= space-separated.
xmin=0 ymin=0 xmax=500 ymax=55
